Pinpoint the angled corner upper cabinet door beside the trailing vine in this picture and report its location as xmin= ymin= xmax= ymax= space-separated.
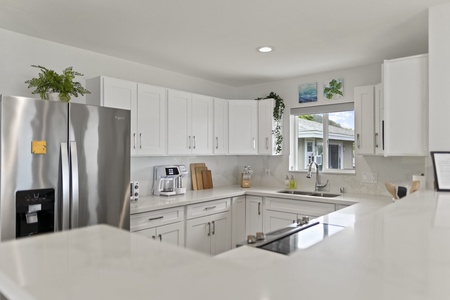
xmin=228 ymin=100 xmax=258 ymax=155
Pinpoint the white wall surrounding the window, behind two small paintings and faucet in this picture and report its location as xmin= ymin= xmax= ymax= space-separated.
xmin=238 ymin=62 xmax=425 ymax=195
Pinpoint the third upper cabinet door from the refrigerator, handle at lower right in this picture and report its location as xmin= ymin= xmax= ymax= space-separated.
xmin=167 ymin=90 xmax=192 ymax=155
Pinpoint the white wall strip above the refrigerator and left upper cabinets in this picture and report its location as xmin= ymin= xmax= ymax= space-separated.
xmin=0 ymin=29 xmax=237 ymax=103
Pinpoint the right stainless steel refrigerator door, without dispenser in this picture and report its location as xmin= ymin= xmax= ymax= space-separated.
xmin=69 ymin=103 xmax=130 ymax=230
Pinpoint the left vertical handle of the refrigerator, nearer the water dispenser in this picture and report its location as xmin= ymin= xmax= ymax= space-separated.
xmin=61 ymin=143 xmax=70 ymax=230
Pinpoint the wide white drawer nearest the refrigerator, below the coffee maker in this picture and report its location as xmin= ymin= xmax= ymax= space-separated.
xmin=130 ymin=206 xmax=184 ymax=232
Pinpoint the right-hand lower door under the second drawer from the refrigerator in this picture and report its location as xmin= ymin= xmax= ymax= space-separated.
xmin=211 ymin=213 xmax=231 ymax=255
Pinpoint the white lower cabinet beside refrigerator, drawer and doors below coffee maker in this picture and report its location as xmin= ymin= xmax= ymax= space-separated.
xmin=130 ymin=206 xmax=184 ymax=247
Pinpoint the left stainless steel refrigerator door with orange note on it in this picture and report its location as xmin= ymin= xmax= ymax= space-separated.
xmin=0 ymin=96 xmax=68 ymax=241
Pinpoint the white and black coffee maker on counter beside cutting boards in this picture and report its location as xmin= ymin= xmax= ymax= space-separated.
xmin=153 ymin=165 xmax=188 ymax=196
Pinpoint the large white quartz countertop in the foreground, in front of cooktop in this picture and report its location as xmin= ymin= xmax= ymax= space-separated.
xmin=0 ymin=191 xmax=450 ymax=300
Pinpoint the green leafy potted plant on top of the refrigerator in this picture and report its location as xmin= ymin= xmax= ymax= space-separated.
xmin=25 ymin=65 xmax=91 ymax=102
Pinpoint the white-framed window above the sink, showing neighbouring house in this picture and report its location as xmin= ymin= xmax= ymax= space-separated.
xmin=289 ymin=102 xmax=355 ymax=173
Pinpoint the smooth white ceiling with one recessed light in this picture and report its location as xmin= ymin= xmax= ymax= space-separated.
xmin=0 ymin=0 xmax=449 ymax=87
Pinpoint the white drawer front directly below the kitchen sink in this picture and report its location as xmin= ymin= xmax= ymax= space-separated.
xmin=265 ymin=197 xmax=335 ymax=217
